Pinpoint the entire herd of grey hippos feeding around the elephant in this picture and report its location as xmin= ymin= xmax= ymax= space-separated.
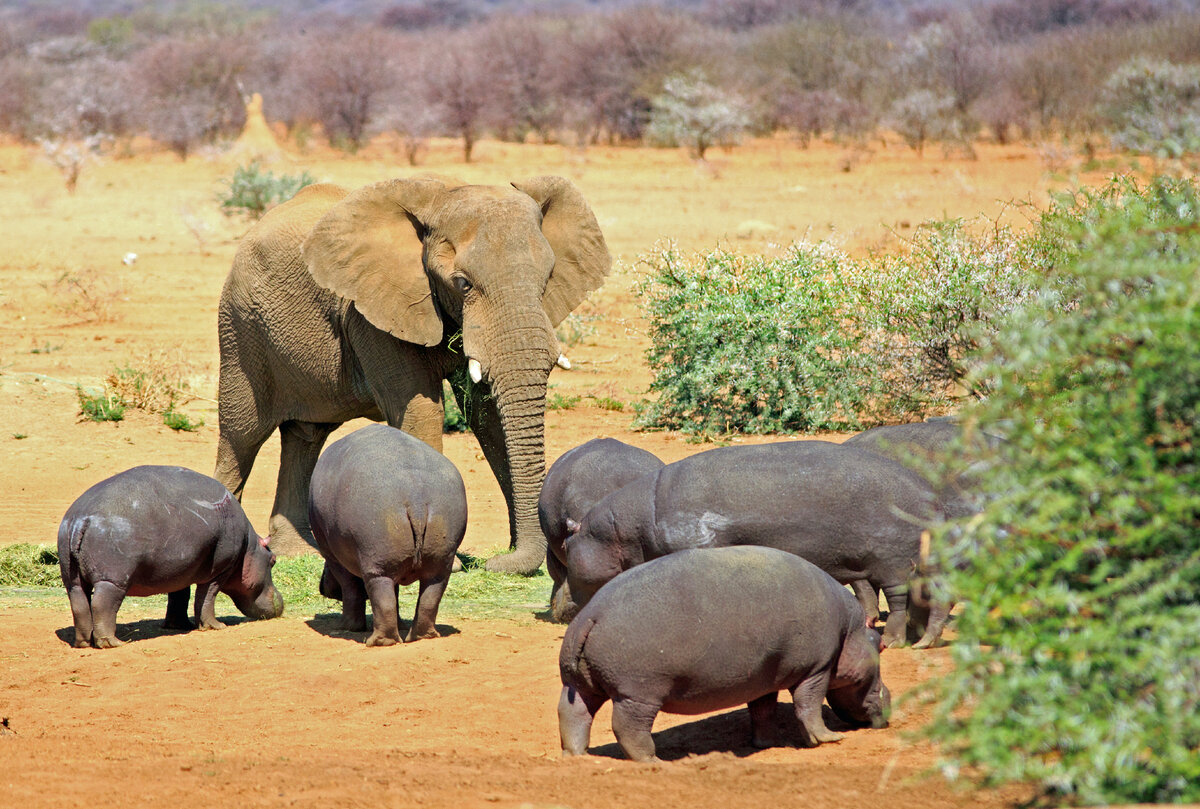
xmin=58 ymin=419 xmax=993 ymax=761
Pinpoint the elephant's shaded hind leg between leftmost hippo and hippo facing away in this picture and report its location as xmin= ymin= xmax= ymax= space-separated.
xmin=270 ymin=421 xmax=340 ymax=553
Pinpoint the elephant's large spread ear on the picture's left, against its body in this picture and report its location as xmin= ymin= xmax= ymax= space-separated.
xmin=301 ymin=178 xmax=445 ymax=346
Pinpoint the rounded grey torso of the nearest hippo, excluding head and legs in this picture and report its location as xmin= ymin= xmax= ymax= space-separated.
xmin=559 ymin=546 xmax=862 ymax=713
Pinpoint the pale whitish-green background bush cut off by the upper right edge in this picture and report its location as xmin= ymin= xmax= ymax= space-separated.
xmin=1100 ymin=58 xmax=1200 ymax=157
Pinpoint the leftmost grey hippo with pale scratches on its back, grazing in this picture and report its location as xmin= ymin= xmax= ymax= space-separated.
xmin=59 ymin=466 xmax=283 ymax=649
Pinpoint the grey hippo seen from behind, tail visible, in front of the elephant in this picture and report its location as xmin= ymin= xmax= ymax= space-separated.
xmin=308 ymin=424 xmax=467 ymax=646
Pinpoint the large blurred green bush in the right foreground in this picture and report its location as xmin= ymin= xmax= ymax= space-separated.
xmin=928 ymin=179 xmax=1200 ymax=805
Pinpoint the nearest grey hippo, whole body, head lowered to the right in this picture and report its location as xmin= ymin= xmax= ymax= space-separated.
xmin=558 ymin=546 xmax=892 ymax=761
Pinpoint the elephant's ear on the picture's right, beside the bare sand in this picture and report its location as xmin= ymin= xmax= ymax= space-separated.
xmin=512 ymin=176 xmax=612 ymax=325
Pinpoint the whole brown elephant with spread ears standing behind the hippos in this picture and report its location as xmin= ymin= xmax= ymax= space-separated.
xmin=215 ymin=175 xmax=612 ymax=574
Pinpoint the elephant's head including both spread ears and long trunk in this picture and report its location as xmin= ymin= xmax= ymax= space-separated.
xmin=302 ymin=176 xmax=611 ymax=571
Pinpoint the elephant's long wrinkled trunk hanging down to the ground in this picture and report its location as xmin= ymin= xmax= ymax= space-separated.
xmin=472 ymin=302 xmax=558 ymax=574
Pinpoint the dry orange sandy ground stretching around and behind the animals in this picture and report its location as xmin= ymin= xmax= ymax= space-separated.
xmin=0 ymin=129 xmax=1099 ymax=809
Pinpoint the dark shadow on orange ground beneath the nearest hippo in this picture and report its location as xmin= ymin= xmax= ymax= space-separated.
xmin=588 ymin=694 xmax=850 ymax=761
